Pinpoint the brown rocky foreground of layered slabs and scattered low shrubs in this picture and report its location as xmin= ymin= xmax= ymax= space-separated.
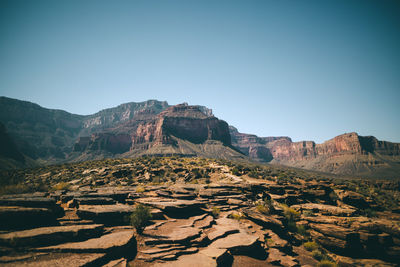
xmin=0 ymin=159 xmax=400 ymax=266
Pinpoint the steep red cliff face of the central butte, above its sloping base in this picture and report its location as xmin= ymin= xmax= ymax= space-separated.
xmin=75 ymin=104 xmax=231 ymax=153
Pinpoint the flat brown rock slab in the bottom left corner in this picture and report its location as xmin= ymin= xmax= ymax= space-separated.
xmin=1 ymin=253 xmax=105 ymax=267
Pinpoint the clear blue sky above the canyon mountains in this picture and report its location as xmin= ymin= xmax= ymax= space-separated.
xmin=0 ymin=0 xmax=400 ymax=142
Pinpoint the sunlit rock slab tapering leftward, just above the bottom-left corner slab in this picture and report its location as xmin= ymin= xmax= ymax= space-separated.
xmin=38 ymin=230 xmax=136 ymax=253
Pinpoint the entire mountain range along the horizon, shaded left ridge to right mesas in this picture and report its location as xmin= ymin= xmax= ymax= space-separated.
xmin=0 ymin=97 xmax=400 ymax=178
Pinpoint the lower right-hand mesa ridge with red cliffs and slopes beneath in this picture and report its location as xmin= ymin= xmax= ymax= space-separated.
xmin=230 ymin=127 xmax=400 ymax=178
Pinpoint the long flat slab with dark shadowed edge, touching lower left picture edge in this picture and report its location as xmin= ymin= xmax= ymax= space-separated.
xmin=0 ymin=224 xmax=103 ymax=247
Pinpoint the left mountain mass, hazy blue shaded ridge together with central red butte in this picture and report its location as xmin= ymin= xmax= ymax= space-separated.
xmin=0 ymin=97 xmax=244 ymax=168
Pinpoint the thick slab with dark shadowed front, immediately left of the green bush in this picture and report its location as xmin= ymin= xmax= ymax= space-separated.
xmin=76 ymin=204 xmax=134 ymax=225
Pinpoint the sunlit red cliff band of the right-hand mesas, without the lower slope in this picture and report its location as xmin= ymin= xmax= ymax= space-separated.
xmin=230 ymin=126 xmax=400 ymax=170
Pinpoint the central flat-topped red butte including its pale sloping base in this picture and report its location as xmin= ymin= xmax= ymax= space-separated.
xmin=74 ymin=104 xmax=243 ymax=160
